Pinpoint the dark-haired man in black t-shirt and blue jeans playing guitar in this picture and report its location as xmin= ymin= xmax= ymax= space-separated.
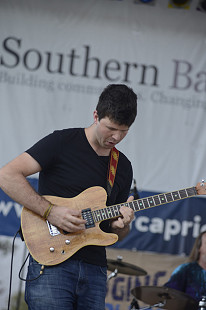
xmin=0 ymin=84 xmax=137 ymax=310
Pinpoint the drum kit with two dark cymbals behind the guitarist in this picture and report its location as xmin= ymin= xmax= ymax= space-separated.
xmin=107 ymin=256 xmax=199 ymax=310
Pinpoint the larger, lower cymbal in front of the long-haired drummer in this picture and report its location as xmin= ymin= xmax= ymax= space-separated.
xmin=131 ymin=286 xmax=198 ymax=310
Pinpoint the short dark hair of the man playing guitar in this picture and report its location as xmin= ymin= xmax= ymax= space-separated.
xmin=96 ymin=84 xmax=137 ymax=127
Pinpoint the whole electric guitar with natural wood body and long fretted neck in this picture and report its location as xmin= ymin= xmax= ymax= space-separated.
xmin=21 ymin=182 xmax=206 ymax=266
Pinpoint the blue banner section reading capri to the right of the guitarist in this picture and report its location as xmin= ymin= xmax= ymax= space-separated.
xmin=113 ymin=192 xmax=206 ymax=255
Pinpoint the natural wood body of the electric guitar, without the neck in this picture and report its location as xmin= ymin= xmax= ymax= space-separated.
xmin=21 ymin=187 xmax=118 ymax=265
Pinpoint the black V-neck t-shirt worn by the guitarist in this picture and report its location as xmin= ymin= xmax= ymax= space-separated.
xmin=26 ymin=128 xmax=132 ymax=266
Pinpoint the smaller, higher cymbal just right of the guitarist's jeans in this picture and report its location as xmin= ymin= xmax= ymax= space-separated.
xmin=107 ymin=259 xmax=147 ymax=276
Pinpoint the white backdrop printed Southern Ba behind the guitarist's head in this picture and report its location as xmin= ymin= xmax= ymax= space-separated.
xmin=0 ymin=0 xmax=206 ymax=191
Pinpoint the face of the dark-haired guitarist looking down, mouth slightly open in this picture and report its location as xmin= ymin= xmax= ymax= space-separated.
xmin=94 ymin=114 xmax=129 ymax=149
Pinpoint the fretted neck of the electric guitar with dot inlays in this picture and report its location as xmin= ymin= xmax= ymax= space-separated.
xmin=92 ymin=187 xmax=197 ymax=223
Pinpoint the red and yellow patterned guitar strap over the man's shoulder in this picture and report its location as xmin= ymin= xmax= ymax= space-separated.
xmin=107 ymin=147 xmax=119 ymax=196
